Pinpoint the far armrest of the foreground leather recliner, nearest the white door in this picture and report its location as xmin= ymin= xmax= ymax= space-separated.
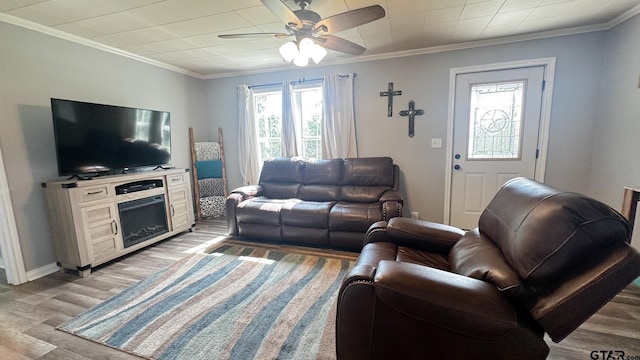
xmin=365 ymin=217 xmax=465 ymax=254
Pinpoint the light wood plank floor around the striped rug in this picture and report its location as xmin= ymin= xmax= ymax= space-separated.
xmin=0 ymin=220 xmax=640 ymax=360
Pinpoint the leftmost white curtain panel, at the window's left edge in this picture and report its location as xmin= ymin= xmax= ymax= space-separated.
xmin=237 ymin=85 xmax=260 ymax=185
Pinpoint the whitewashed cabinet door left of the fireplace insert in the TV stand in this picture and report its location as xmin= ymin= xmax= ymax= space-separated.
xmin=81 ymin=202 xmax=122 ymax=266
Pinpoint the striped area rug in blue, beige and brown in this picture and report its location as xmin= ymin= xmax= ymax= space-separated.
xmin=58 ymin=245 xmax=354 ymax=360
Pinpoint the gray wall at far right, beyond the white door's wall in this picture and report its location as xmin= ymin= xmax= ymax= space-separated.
xmin=589 ymin=15 xmax=640 ymax=249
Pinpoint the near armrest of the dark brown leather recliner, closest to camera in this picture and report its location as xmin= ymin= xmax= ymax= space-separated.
xmin=374 ymin=260 xmax=518 ymax=340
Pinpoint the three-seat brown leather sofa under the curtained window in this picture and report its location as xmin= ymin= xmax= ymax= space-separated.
xmin=227 ymin=157 xmax=403 ymax=251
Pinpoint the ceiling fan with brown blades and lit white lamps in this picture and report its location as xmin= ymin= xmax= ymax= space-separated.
xmin=218 ymin=0 xmax=385 ymax=66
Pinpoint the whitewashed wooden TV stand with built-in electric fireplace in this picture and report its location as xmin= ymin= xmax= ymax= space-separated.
xmin=42 ymin=169 xmax=195 ymax=277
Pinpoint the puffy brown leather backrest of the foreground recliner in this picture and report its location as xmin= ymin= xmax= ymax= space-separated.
xmin=479 ymin=178 xmax=631 ymax=284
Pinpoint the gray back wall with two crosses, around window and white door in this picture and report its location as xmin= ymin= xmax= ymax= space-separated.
xmin=206 ymin=32 xmax=606 ymax=225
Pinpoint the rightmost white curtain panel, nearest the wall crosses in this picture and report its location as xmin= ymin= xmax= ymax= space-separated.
xmin=322 ymin=74 xmax=358 ymax=159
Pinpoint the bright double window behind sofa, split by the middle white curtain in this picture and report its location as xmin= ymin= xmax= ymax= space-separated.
xmin=253 ymin=85 xmax=322 ymax=164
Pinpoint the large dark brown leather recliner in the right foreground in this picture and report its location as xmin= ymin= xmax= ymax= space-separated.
xmin=336 ymin=178 xmax=640 ymax=360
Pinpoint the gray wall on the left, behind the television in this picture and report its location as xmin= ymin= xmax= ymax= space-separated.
xmin=0 ymin=22 xmax=206 ymax=271
